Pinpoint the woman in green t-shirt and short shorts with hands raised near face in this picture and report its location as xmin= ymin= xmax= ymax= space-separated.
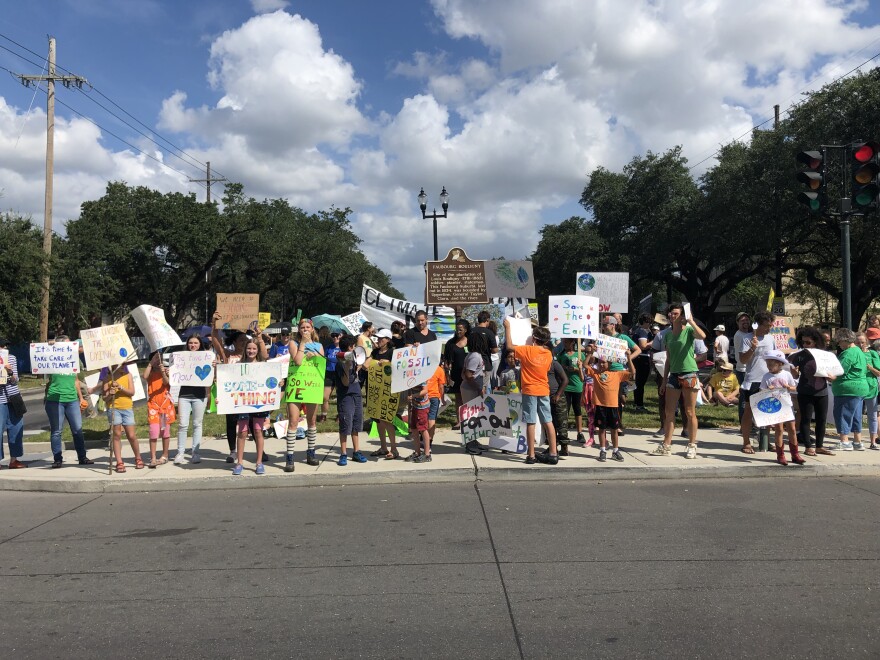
xmin=653 ymin=303 xmax=706 ymax=458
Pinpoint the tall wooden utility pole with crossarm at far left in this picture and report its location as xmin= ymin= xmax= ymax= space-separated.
xmin=16 ymin=37 xmax=89 ymax=341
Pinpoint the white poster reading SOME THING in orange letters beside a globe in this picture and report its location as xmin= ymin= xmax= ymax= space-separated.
xmin=217 ymin=362 xmax=281 ymax=415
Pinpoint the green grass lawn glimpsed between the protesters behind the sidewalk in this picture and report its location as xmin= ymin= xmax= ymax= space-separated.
xmin=25 ymin=383 xmax=739 ymax=442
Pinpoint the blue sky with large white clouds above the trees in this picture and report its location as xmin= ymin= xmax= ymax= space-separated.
xmin=0 ymin=0 xmax=880 ymax=299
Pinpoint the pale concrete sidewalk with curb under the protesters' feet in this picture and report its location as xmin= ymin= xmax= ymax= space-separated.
xmin=6 ymin=429 xmax=880 ymax=493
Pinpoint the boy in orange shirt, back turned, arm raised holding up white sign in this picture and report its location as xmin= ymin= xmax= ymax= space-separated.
xmin=504 ymin=318 xmax=559 ymax=465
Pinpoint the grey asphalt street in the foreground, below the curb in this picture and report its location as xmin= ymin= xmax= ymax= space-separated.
xmin=0 ymin=478 xmax=880 ymax=659
